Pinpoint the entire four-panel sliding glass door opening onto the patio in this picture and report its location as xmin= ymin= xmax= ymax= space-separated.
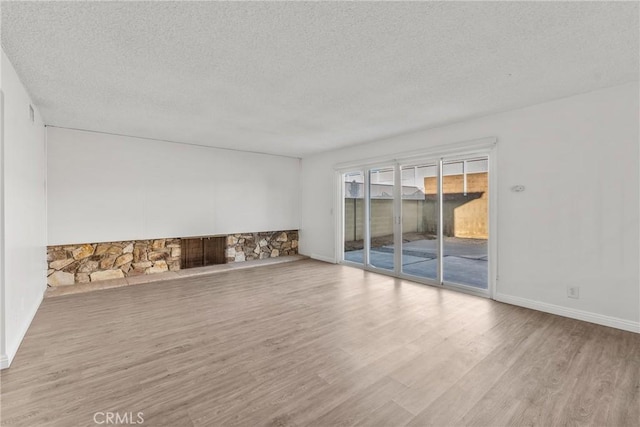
xmin=342 ymin=150 xmax=490 ymax=293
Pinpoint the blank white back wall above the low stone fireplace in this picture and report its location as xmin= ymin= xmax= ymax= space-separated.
xmin=47 ymin=127 xmax=300 ymax=245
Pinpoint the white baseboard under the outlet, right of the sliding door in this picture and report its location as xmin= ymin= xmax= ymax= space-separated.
xmin=495 ymin=293 xmax=640 ymax=333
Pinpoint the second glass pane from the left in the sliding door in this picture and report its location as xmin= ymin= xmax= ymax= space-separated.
xmin=369 ymin=166 xmax=395 ymax=271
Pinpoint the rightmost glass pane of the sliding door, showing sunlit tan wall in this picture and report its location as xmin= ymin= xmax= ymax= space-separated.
xmin=442 ymin=157 xmax=489 ymax=289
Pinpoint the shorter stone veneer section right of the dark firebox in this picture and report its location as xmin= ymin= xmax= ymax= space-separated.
xmin=227 ymin=230 xmax=298 ymax=262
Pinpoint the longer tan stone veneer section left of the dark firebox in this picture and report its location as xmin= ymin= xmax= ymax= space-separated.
xmin=47 ymin=239 xmax=181 ymax=286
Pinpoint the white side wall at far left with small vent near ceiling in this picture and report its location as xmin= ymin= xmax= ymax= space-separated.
xmin=0 ymin=52 xmax=47 ymax=368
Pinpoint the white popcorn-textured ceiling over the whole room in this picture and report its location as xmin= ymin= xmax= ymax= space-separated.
xmin=2 ymin=2 xmax=640 ymax=157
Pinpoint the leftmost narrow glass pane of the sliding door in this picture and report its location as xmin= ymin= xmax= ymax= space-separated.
xmin=342 ymin=171 xmax=365 ymax=264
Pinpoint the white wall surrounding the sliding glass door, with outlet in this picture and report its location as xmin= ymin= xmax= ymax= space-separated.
xmin=300 ymin=83 xmax=640 ymax=331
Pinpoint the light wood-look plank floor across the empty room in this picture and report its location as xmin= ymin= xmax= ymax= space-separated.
xmin=1 ymin=260 xmax=640 ymax=426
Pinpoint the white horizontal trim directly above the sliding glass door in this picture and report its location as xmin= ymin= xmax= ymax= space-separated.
xmin=333 ymin=136 xmax=498 ymax=172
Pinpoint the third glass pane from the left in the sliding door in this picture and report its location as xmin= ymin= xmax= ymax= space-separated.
xmin=400 ymin=161 xmax=439 ymax=281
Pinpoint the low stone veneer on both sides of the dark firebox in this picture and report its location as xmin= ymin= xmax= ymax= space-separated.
xmin=47 ymin=230 xmax=298 ymax=286
